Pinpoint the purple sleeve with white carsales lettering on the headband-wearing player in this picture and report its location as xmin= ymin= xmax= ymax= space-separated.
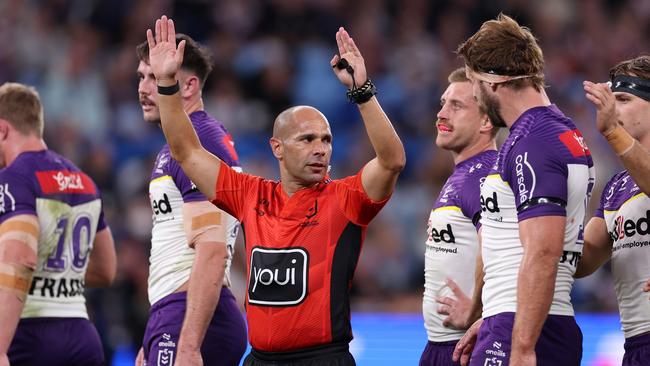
xmin=504 ymin=136 xmax=568 ymax=221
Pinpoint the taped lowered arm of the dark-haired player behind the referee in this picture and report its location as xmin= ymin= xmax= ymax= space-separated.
xmin=176 ymin=201 xmax=230 ymax=365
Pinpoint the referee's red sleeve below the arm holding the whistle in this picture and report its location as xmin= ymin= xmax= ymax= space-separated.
xmin=334 ymin=169 xmax=391 ymax=226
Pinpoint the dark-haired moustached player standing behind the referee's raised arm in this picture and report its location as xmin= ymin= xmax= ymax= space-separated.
xmin=136 ymin=34 xmax=246 ymax=366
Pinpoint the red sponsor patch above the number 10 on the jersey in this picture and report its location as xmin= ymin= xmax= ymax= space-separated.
xmin=36 ymin=170 xmax=97 ymax=194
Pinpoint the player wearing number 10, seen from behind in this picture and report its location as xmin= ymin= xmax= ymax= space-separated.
xmin=0 ymin=83 xmax=117 ymax=366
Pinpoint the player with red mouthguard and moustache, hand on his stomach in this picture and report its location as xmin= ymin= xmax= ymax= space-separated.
xmin=420 ymin=68 xmax=498 ymax=366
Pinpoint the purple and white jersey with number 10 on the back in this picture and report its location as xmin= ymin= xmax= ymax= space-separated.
xmin=0 ymin=150 xmax=106 ymax=318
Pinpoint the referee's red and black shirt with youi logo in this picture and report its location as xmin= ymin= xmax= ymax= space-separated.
xmin=212 ymin=163 xmax=388 ymax=352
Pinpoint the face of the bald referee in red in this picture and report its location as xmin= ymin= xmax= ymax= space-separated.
xmin=280 ymin=109 xmax=332 ymax=186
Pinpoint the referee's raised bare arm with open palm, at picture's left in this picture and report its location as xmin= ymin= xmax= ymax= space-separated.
xmin=147 ymin=15 xmax=221 ymax=200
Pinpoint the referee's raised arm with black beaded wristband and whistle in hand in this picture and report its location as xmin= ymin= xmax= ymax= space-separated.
xmin=330 ymin=28 xmax=406 ymax=201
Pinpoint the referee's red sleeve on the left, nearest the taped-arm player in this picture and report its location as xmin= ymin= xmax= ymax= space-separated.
xmin=211 ymin=161 xmax=263 ymax=221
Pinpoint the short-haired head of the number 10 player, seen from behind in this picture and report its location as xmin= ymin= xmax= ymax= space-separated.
xmin=0 ymin=83 xmax=44 ymax=137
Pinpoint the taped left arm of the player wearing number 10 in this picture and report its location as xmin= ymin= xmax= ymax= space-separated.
xmin=0 ymin=215 xmax=40 ymax=360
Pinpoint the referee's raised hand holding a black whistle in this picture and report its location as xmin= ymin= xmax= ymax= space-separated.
xmin=330 ymin=27 xmax=368 ymax=89
